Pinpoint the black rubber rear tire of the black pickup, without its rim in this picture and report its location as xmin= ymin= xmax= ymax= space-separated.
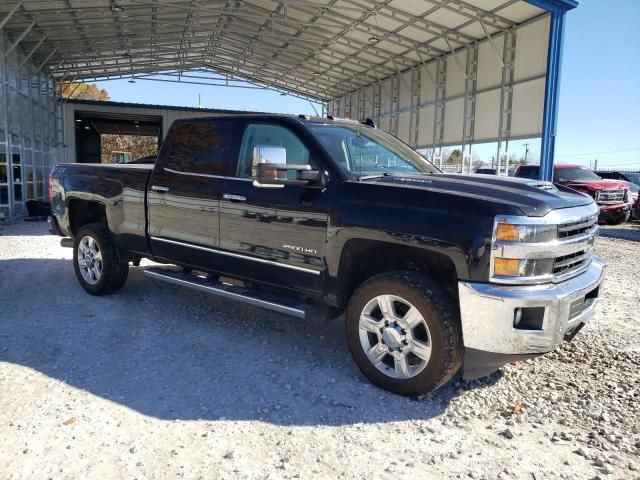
xmin=73 ymin=223 xmax=129 ymax=295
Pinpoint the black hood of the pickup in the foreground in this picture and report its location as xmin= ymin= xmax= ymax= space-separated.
xmin=365 ymin=173 xmax=593 ymax=217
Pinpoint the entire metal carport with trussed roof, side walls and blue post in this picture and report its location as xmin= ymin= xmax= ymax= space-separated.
xmin=0 ymin=0 xmax=577 ymax=219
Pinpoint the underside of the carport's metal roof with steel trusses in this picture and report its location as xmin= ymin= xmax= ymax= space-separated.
xmin=0 ymin=0 xmax=570 ymax=100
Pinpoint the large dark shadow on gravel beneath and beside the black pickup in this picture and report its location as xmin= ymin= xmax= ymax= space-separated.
xmin=0 ymin=259 xmax=499 ymax=425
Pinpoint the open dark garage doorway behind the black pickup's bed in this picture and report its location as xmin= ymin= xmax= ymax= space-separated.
xmin=74 ymin=111 xmax=162 ymax=163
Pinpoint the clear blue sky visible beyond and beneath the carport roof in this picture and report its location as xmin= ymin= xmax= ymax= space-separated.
xmin=92 ymin=0 xmax=640 ymax=168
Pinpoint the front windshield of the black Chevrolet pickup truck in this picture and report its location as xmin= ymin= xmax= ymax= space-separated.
xmin=309 ymin=123 xmax=439 ymax=178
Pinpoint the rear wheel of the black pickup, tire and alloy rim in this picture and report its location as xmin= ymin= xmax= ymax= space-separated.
xmin=73 ymin=223 xmax=129 ymax=295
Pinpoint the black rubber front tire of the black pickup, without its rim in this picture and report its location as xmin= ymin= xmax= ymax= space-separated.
xmin=346 ymin=271 xmax=464 ymax=396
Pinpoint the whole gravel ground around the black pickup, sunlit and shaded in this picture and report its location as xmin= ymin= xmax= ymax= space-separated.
xmin=0 ymin=223 xmax=640 ymax=480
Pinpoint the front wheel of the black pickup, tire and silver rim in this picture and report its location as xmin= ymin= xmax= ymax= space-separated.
xmin=346 ymin=271 xmax=463 ymax=396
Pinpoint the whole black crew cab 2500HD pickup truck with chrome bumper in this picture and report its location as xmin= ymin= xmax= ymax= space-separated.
xmin=49 ymin=115 xmax=604 ymax=395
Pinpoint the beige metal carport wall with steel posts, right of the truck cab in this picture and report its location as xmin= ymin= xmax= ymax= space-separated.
xmin=328 ymin=14 xmax=550 ymax=163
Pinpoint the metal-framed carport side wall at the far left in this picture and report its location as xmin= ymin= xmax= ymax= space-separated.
xmin=0 ymin=31 xmax=61 ymax=218
